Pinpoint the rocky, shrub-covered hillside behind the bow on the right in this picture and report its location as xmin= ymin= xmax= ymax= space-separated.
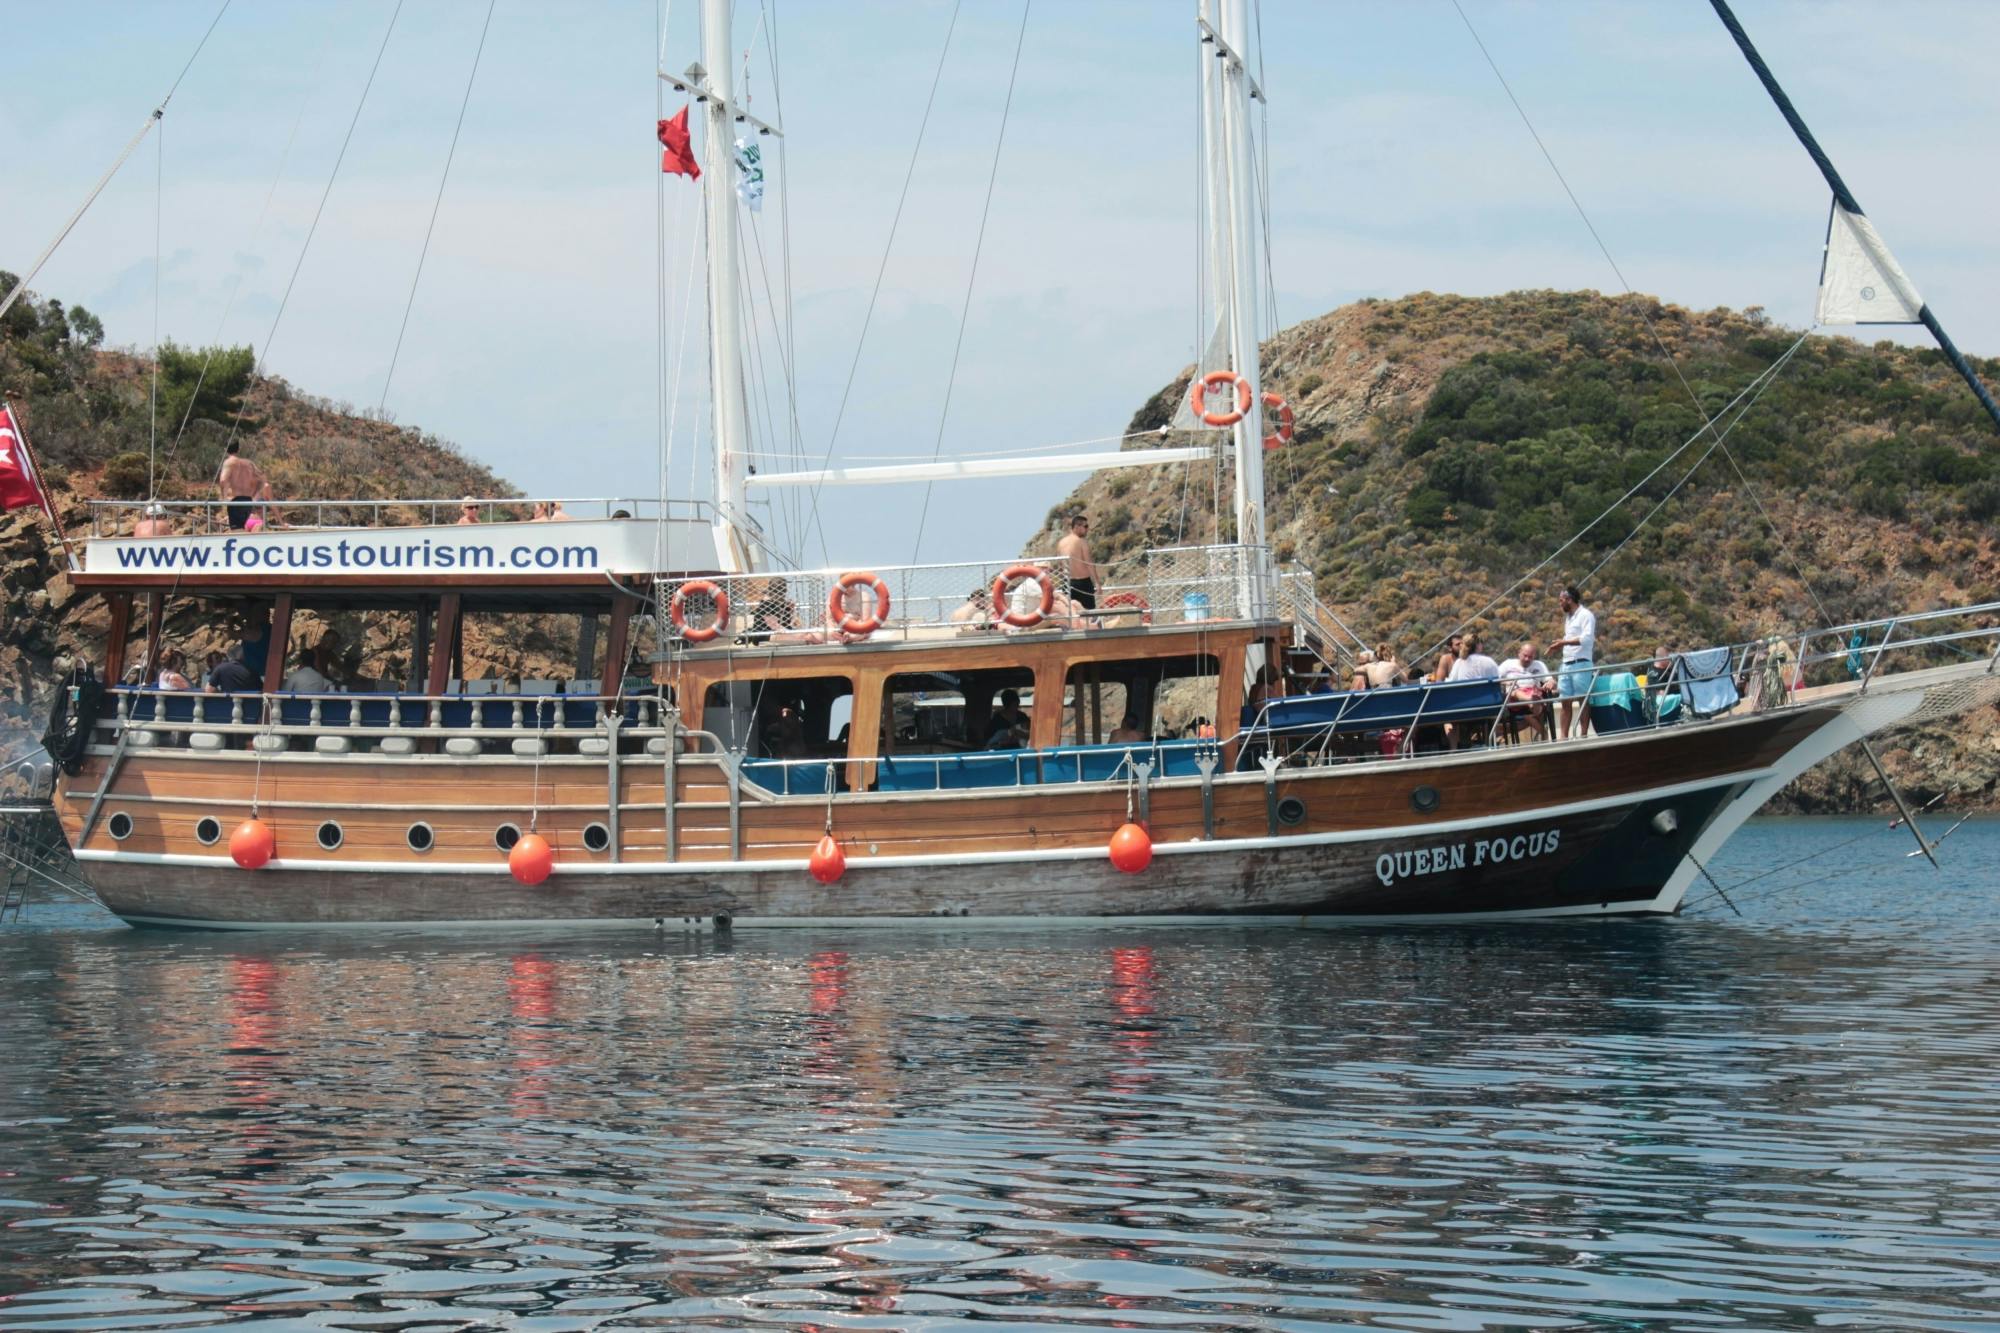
xmin=1032 ymin=292 xmax=2000 ymax=811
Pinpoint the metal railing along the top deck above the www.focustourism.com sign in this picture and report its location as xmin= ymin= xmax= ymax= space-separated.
xmin=90 ymin=496 xmax=712 ymax=536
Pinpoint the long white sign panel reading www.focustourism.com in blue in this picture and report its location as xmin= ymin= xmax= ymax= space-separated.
xmin=84 ymin=518 xmax=714 ymax=574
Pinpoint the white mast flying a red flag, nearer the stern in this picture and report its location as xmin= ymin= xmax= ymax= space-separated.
xmin=702 ymin=0 xmax=760 ymax=572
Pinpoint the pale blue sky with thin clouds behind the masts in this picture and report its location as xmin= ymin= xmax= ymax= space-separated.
xmin=0 ymin=0 xmax=2000 ymax=564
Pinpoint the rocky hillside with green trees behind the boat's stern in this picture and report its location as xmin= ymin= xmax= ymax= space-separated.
xmin=0 ymin=274 xmax=574 ymax=761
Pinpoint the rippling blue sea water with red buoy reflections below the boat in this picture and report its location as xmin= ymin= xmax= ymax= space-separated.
xmin=0 ymin=821 xmax=2000 ymax=1329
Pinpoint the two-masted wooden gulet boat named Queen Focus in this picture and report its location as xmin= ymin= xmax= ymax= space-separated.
xmin=35 ymin=0 xmax=2000 ymax=929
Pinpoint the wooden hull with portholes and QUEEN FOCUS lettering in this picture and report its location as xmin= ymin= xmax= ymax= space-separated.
xmin=58 ymin=709 xmax=1838 ymax=929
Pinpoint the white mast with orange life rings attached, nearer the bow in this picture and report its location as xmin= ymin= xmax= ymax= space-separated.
xmin=1210 ymin=0 xmax=1264 ymax=546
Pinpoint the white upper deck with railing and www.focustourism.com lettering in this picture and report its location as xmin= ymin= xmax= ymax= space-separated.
xmin=74 ymin=498 xmax=720 ymax=590
